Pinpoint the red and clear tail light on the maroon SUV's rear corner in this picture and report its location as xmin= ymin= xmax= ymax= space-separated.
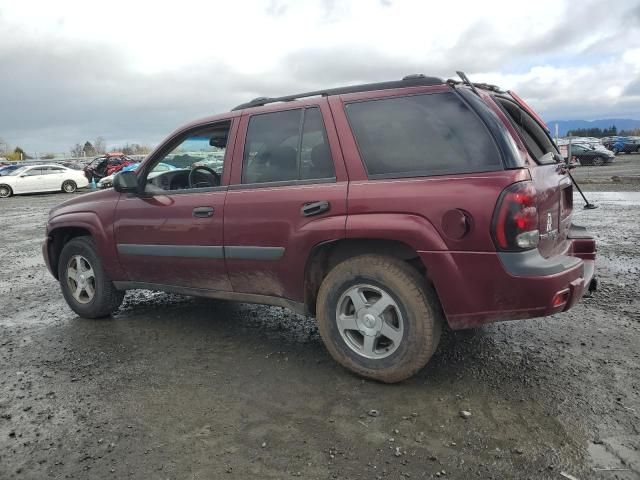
xmin=493 ymin=182 xmax=540 ymax=251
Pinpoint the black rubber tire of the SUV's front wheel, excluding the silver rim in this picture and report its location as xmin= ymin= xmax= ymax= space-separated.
xmin=58 ymin=237 xmax=125 ymax=318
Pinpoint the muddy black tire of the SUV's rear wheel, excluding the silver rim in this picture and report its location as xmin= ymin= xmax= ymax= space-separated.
xmin=316 ymin=255 xmax=443 ymax=383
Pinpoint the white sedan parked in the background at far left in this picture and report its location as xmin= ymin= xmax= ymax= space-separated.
xmin=0 ymin=165 xmax=89 ymax=198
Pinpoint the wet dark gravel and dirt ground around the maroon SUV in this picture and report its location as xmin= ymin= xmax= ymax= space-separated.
xmin=0 ymin=156 xmax=640 ymax=480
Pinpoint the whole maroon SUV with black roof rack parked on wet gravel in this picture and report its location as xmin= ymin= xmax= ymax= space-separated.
xmin=43 ymin=75 xmax=595 ymax=382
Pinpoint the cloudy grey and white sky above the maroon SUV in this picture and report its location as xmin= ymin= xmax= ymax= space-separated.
xmin=0 ymin=0 xmax=640 ymax=152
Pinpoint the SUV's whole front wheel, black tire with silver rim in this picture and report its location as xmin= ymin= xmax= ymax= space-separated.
xmin=58 ymin=237 xmax=124 ymax=318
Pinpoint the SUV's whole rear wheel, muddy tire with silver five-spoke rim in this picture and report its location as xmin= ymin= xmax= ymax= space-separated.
xmin=317 ymin=255 xmax=442 ymax=383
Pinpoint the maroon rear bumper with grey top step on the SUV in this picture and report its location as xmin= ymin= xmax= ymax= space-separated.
xmin=419 ymin=227 xmax=596 ymax=329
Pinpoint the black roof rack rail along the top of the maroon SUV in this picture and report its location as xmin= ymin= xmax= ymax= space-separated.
xmin=232 ymin=73 xmax=445 ymax=111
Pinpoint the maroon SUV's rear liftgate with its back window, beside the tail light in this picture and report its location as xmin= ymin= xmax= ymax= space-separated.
xmin=494 ymin=95 xmax=573 ymax=257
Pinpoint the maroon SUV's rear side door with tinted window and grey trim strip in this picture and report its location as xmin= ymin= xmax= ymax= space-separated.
xmin=224 ymin=99 xmax=348 ymax=301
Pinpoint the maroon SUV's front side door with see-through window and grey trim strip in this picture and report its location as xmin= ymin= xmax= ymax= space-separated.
xmin=114 ymin=120 xmax=237 ymax=291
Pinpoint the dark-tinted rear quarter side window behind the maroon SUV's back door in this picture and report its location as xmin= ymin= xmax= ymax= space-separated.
xmin=345 ymin=93 xmax=502 ymax=178
